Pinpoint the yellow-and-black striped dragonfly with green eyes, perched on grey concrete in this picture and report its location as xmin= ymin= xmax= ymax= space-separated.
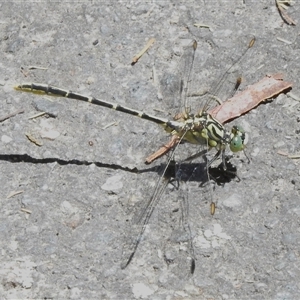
xmin=15 ymin=34 xmax=254 ymax=274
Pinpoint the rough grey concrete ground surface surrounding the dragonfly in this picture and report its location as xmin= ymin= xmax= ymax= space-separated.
xmin=0 ymin=0 xmax=300 ymax=299
